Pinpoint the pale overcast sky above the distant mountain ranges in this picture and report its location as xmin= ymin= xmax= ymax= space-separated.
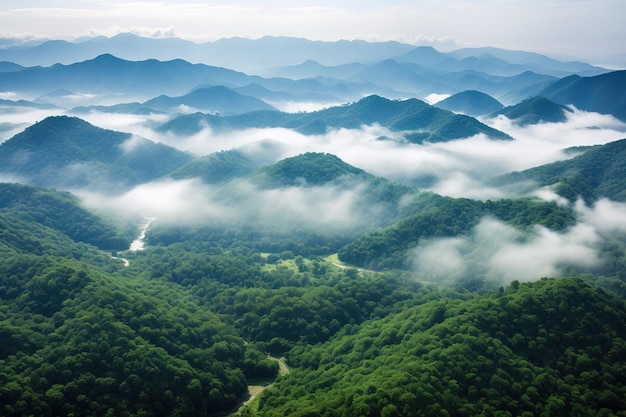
xmin=0 ymin=0 xmax=626 ymax=64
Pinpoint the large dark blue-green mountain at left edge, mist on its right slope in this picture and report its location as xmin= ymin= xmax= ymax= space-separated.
xmin=0 ymin=116 xmax=191 ymax=191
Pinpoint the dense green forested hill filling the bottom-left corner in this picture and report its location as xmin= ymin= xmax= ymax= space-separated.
xmin=0 ymin=249 xmax=277 ymax=417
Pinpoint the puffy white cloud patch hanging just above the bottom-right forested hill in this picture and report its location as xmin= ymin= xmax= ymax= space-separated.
xmin=410 ymin=214 xmax=601 ymax=285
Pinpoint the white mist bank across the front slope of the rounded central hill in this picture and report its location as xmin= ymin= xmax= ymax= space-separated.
xmin=77 ymin=174 xmax=382 ymax=235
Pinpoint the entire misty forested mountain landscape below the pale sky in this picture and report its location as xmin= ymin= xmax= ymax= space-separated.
xmin=0 ymin=35 xmax=626 ymax=416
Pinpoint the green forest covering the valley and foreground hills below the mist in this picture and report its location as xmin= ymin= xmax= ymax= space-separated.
xmin=0 ymin=179 xmax=626 ymax=417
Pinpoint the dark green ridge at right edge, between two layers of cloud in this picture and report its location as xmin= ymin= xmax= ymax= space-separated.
xmin=492 ymin=139 xmax=626 ymax=202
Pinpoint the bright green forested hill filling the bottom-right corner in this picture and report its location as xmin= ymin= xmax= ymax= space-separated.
xmin=258 ymin=279 xmax=626 ymax=417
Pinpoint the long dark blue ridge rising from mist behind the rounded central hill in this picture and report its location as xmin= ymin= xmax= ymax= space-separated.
xmin=159 ymin=96 xmax=510 ymax=143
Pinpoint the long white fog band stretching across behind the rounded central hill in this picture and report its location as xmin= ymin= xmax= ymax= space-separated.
xmin=56 ymin=102 xmax=626 ymax=199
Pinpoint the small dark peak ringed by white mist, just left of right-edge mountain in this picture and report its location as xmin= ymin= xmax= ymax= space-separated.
xmin=489 ymin=96 xmax=573 ymax=126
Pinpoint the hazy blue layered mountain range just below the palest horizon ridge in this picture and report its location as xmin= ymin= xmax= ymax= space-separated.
xmin=0 ymin=40 xmax=619 ymax=109
